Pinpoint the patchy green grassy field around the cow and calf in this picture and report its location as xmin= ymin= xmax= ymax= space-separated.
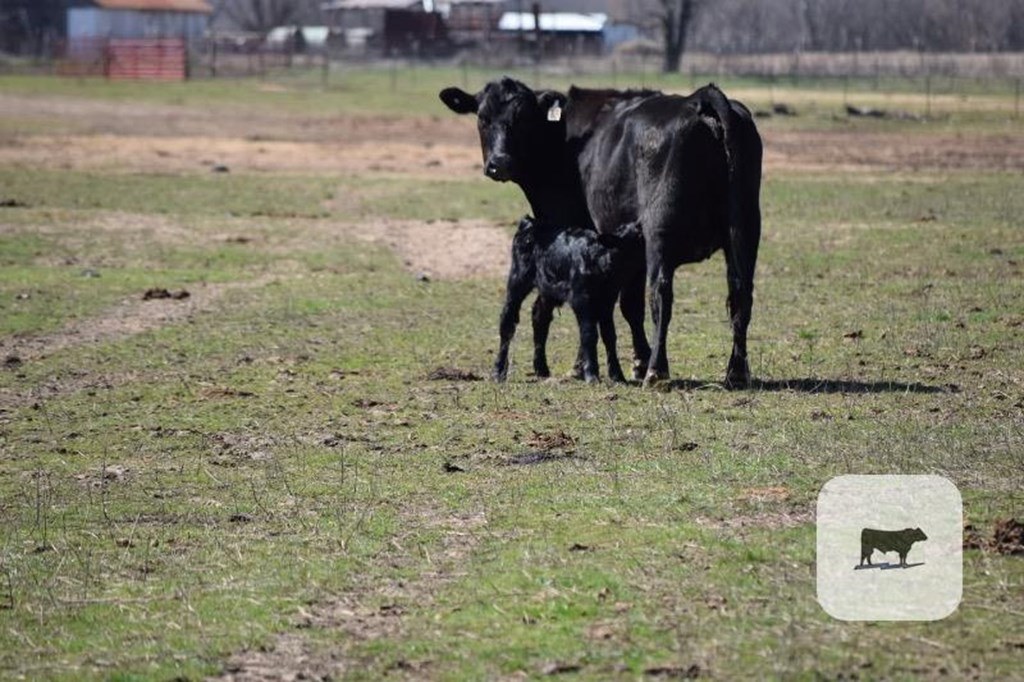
xmin=0 ymin=69 xmax=1024 ymax=680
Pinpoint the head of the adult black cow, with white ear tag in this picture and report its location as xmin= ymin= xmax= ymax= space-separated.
xmin=440 ymin=78 xmax=565 ymax=183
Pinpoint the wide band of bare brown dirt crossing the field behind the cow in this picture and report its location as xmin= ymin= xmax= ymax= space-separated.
xmin=0 ymin=95 xmax=1024 ymax=177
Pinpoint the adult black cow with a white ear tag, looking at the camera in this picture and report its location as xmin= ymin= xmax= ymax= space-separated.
xmin=440 ymin=78 xmax=762 ymax=386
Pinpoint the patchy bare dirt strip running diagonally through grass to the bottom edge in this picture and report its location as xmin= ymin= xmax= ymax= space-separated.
xmin=211 ymin=509 xmax=486 ymax=682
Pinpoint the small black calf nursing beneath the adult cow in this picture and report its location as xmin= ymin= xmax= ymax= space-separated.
xmin=494 ymin=217 xmax=643 ymax=382
